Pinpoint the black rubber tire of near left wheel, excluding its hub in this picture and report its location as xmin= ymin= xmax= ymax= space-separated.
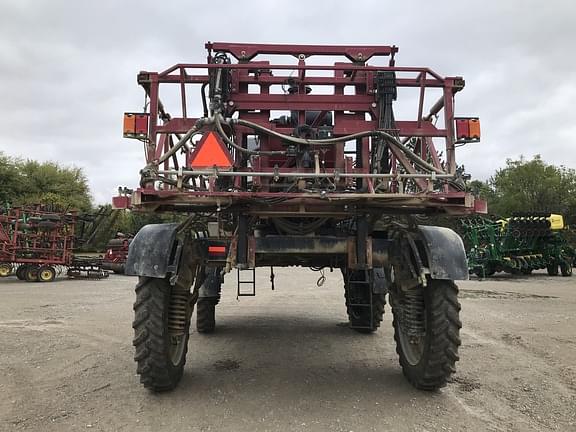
xmin=132 ymin=277 xmax=190 ymax=392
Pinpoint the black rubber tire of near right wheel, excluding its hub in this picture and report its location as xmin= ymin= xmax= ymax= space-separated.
xmin=391 ymin=280 xmax=462 ymax=391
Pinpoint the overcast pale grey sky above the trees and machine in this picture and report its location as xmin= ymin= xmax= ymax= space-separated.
xmin=0 ymin=0 xmax=576 ymax=203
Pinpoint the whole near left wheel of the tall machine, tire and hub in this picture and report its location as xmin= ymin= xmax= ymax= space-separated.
xmin=132 ymin=277 xmax=193 ymax=392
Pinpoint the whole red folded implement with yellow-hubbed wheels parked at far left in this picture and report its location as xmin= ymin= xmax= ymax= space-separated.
xmin=0 ymin=206 xmax=107 ymax=282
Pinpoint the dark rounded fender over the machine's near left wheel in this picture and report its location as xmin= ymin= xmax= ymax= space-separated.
xmin=125 ymin=223 xmax=179 ymax=278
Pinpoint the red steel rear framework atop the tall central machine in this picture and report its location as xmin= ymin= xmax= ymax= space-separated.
xmin=115 ymin=42 xmax=484 ymax=215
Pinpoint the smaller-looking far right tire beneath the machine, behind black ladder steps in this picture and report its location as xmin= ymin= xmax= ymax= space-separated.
xmin=344 ymin=271 xmax=386 ymax=334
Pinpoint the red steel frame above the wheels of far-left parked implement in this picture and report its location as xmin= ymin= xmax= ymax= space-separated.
xmin=0 ymin=206 xmax=76 ymax=266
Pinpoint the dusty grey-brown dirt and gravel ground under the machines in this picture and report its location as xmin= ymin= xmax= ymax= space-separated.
xmin=0 ymin=268 xmax=576 ymax=432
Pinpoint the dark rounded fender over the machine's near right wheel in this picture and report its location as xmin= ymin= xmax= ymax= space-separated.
xmin=418 ymin=225 xmax=468 ymax=280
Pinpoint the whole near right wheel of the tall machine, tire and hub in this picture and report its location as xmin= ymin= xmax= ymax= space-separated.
xmin=390 ymin=280 xmax=462 ymax=391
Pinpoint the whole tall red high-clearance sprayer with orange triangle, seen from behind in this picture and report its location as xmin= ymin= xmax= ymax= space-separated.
xmin=114 ymin=43 xmax=486 ymax=390
